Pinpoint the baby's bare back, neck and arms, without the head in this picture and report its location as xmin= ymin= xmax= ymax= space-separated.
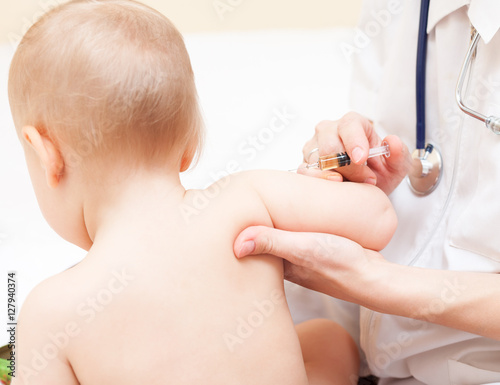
xmin=14 ymin=172 xmax=395 ymax=385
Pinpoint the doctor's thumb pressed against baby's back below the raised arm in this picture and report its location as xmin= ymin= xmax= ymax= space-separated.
xmin=233 ymin=226 xmax=289 ymax=259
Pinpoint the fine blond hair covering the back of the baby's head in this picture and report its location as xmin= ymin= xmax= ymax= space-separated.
xmin=9 ymin=0 xmax=202 ymax=175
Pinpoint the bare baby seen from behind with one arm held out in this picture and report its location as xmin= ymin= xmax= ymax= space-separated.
xmin=9 ymin=0 xmax=396 ymax=385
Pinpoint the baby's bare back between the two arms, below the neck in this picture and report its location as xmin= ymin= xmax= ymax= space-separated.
xmin=48 ymin=184 xmax=306 ymax=385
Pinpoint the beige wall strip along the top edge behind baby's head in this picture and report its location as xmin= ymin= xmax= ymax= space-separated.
xmin=0 ymin=0 xmax=362 ymax=42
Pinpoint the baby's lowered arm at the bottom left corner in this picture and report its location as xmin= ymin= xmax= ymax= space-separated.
xmin=12 ymin=278 xmax=79 ymax=385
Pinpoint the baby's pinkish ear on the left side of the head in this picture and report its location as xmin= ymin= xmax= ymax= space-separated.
xmin=22 ymin=126 xmax=64 ymax=189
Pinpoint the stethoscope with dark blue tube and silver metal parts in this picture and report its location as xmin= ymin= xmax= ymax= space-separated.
xmin=408 ymin=0 xmax=500 ymax=195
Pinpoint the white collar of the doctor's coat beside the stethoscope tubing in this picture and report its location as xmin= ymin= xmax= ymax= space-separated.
xmin=427 ymin=0 xmax=500 ymax=44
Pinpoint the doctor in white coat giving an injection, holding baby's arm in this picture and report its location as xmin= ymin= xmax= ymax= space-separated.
xmin=235 ymin=0 xmax=500 ymax=385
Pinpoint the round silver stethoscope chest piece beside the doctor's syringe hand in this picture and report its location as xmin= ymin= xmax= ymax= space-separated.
xmin=408 ymin=144 xmax=443 ymax=195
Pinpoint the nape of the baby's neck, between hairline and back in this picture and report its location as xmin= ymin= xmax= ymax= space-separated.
xmin=83 ymin=172 xmax=186 ymax=243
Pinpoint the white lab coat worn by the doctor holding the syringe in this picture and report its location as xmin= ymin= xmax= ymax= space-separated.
xmin=342 ymin=0 xmax=500 ymax=385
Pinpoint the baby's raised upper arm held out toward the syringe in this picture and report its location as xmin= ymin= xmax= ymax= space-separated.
xmin=244 ymin=171 xmax=397 ymax=250
